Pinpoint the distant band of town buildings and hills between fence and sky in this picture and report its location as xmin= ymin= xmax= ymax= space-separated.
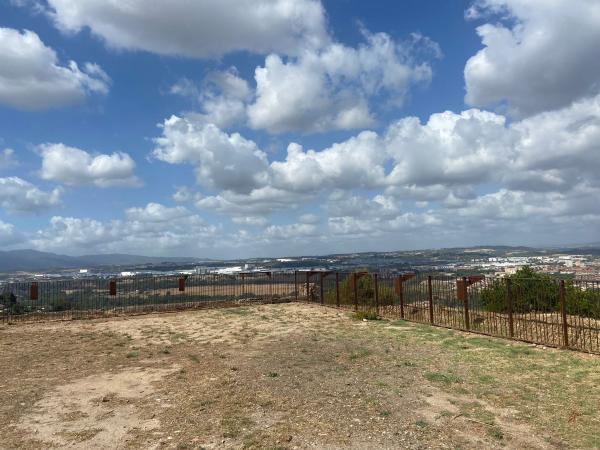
xmin=0 ymin=245 xmax=600 ymax=282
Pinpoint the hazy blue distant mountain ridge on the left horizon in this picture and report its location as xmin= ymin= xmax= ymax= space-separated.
xmin=0 ymin=250 xmax=196 ymax=272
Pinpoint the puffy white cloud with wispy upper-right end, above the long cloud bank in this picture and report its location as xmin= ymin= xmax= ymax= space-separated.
xmin=247 ymin=31 xmax=439 ymax=133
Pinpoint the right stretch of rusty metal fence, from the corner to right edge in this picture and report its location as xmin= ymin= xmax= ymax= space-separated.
xmin=299 ymin=272 xmax=600 ymax=353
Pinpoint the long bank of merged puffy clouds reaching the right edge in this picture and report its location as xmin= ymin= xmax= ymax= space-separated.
xmin=154 ymin=91 xmax=600 ymax=220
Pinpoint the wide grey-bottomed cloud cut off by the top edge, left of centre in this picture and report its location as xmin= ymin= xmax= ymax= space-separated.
xmin=47 ymin=0 xmax=329 ymax=57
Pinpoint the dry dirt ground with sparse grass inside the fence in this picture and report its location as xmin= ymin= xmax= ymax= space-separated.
xmin=0 ymin=303 xmax=600 ymax=449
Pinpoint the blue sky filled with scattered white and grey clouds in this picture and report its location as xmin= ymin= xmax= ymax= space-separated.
xmin=0 ymin=0 xmax=600 ymax=258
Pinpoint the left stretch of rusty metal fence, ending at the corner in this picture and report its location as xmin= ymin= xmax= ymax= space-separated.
xmin=0 ymin=272 xmax=297 ymax=322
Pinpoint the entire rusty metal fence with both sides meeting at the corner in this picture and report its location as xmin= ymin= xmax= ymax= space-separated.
xmin=0 ymin=271 xmax=600 ymax=353
